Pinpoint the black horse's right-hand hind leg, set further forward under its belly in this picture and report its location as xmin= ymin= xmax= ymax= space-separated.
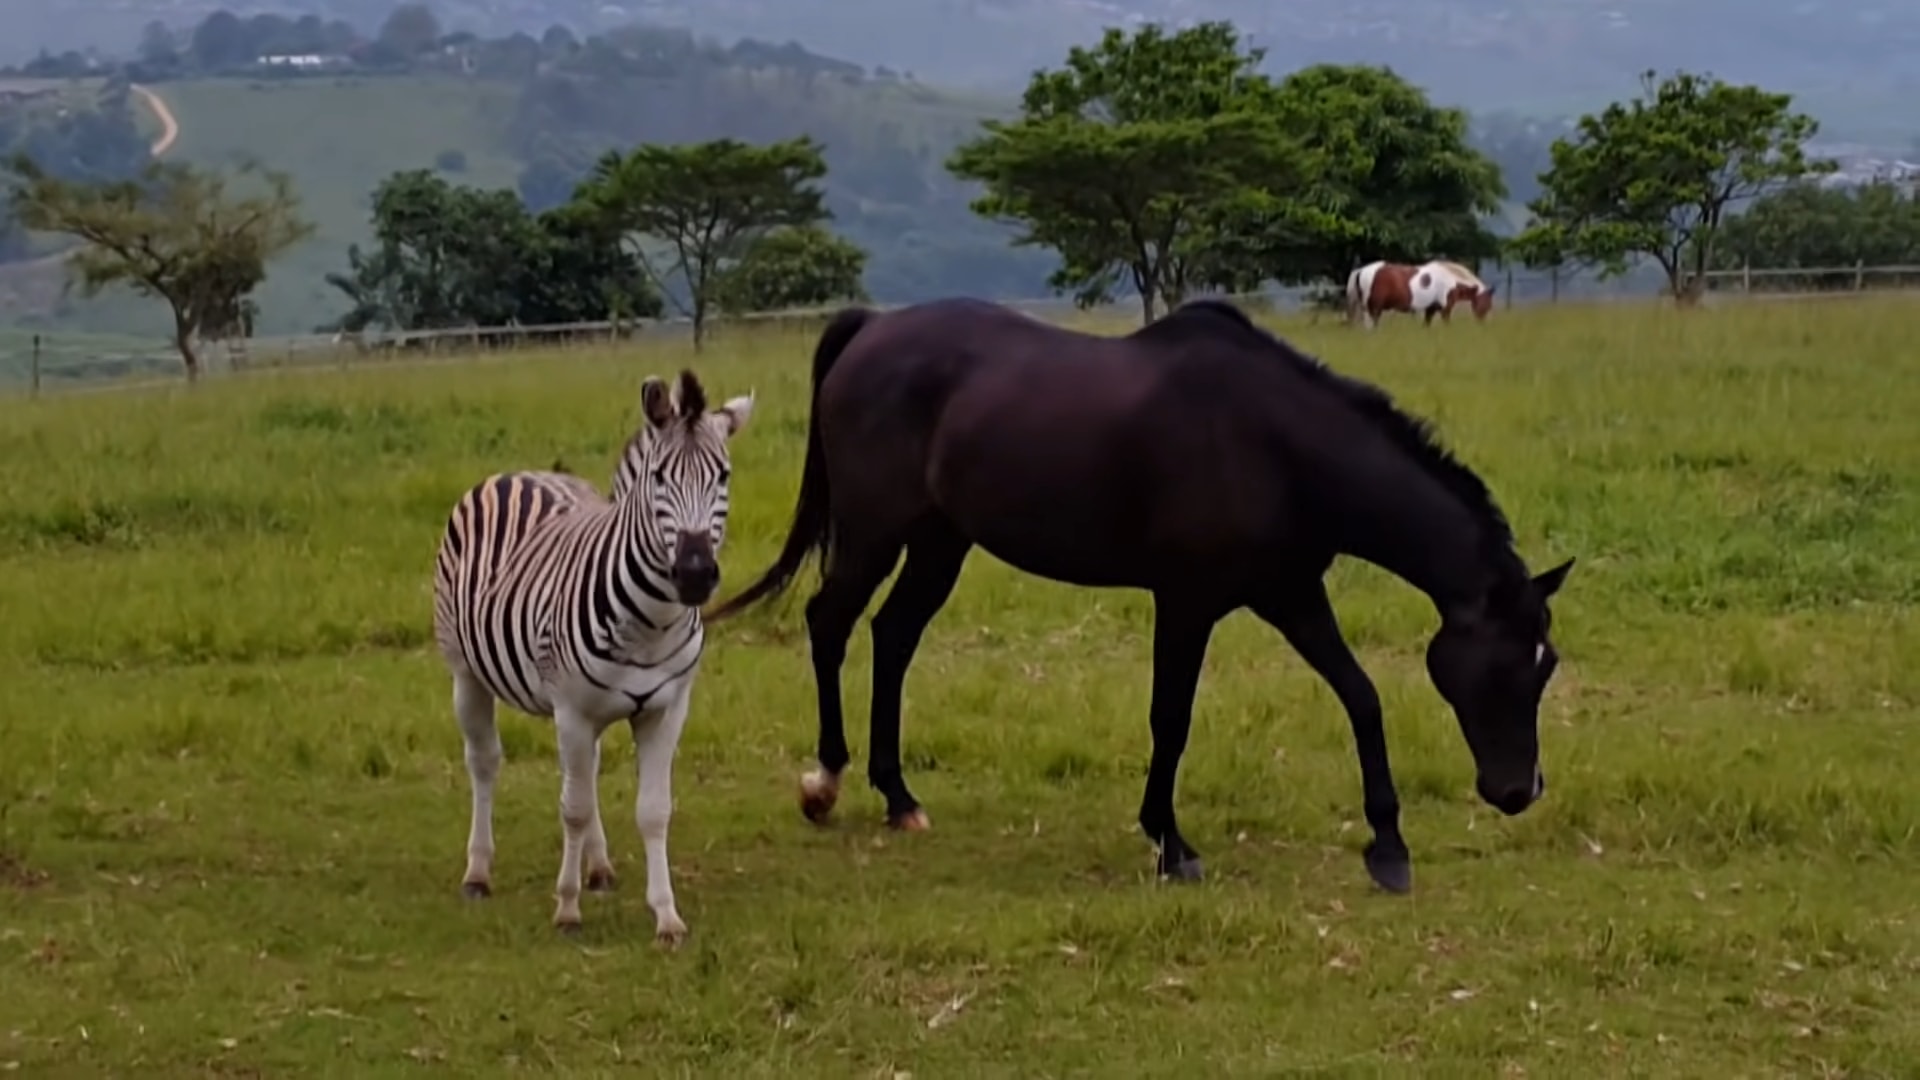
xmin=866 ymin=519 xmax=973 ymax=830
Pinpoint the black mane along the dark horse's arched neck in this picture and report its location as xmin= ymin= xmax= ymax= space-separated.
xmin=1154 ymin=298 xmax=1513 ymax=552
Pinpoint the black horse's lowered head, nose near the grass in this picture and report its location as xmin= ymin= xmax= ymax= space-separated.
xmin=1427 ymin=559 xmax=1572 ymax=815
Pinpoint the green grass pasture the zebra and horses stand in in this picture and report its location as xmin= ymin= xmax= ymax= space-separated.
xmin=0 ymin=297 xmax=1920 ymax=1078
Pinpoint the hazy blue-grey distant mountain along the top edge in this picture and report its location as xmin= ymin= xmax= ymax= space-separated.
xmin=15 ymin=0 xmax=1920 ymax=135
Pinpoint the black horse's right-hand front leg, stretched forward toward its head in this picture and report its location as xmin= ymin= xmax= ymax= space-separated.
xmin=1252 ymin=578 xmax=1413 ymax=892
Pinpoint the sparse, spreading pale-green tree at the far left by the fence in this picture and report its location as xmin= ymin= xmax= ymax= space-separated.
xmin=8 ymin=154 xmax=313 ymax=380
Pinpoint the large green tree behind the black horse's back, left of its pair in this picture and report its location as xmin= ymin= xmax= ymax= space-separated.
xmin=947 ymin=21 xmax=1306 ymax=321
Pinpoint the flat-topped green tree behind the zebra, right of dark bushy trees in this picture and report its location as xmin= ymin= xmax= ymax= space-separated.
xmin=580 ymin=135 xmax=829 ymax=350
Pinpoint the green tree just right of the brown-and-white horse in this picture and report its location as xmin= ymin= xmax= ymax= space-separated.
xmin=1515 ymin=71 xmax=1834 ymax=302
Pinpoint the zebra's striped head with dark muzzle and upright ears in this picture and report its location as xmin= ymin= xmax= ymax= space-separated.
xmin=614 ymin=371 xmax=753 ymax=607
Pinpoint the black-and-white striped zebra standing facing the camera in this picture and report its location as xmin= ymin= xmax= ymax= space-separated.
xmin=434 ymin=371 xmax=753 ymax=945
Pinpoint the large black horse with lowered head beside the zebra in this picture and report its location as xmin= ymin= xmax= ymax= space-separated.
xmin=710 ymin=300 xmax=1572 ymax=892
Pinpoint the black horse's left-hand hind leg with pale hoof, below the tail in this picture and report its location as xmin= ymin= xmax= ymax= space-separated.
xmin=801 ymin=536 xmax=900 ymax=822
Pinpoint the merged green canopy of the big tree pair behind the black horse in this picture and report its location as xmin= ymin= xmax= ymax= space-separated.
xmin=948 ymin=23 xmax=1507 ymax=319
